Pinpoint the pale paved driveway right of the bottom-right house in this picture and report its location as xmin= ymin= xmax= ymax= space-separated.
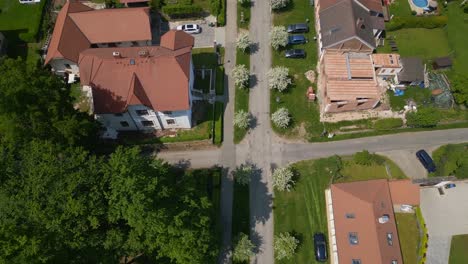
xmin=421 ymin=182 xmax=468 ymax=264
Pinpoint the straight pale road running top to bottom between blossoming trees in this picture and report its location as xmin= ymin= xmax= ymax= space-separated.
xmin=245 ymin=1 xmax=274 ymax=263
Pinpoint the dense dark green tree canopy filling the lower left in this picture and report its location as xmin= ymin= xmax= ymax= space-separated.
xmin=0 ymin=59 xmax=218 ymax=263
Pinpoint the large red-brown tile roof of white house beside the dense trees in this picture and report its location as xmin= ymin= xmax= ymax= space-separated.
xmin=79 ymin=33 xmax=192 ymax=114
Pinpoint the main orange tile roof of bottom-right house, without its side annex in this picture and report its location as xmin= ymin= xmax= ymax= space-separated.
xmin=331 ymin=180 xmax=403 ymax=264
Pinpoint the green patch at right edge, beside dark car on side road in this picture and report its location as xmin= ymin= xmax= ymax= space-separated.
xmin=429 ymin=143 xmax=468 ymax=179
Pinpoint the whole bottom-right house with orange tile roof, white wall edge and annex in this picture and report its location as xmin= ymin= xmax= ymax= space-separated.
xmin=325 ymin=179 xmax=419 ymax=264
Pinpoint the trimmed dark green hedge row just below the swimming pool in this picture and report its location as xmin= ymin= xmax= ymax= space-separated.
xmin=385 ymin=16 xmax=448 ymax=31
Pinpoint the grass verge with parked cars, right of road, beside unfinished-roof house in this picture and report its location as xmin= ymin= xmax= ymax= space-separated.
xmin=270 ymin=0 xmax=323 ymax=137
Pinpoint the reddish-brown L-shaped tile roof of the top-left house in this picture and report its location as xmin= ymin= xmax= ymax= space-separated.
xmin=45 ymin=2 xmax=151 ymax=64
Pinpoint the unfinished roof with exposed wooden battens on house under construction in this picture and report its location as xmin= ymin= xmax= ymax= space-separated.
xmin=324 ymin=52 xmax=380 ymax=101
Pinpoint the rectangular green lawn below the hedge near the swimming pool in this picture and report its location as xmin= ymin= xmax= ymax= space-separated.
xmin=378 ymin=28 xmax=451 ymax=61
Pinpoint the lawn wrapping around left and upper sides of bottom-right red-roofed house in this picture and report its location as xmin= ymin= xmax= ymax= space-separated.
xmin=273 ymin=157 xmax=409 ymax=263
